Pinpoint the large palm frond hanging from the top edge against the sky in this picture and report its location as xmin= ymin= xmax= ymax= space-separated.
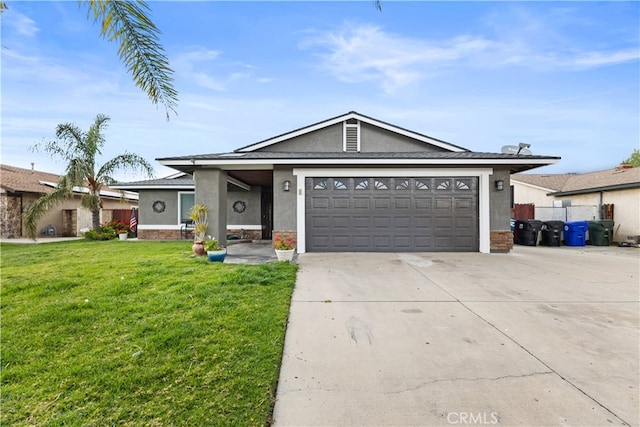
xmin=79 ymin=0 xmax=178 ymax=120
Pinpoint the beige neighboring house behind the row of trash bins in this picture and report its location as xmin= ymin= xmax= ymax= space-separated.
xmin=511 ymin=165 xmax=640 ymax=242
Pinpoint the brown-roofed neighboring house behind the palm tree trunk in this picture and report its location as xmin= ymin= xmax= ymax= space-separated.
xmin=0 ymin=165 xmax=138 ymax=238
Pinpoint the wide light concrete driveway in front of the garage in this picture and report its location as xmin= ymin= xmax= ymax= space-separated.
xmin=273 ymin=246 xmax=640 ymax=427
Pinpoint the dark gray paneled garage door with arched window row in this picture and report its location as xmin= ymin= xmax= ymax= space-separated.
xmin=305 ymin=177 xmax=479 ymax=252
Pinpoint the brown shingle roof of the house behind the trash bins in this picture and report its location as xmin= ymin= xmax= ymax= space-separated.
xmin=511 ymin=168 xmax=640 ymax=194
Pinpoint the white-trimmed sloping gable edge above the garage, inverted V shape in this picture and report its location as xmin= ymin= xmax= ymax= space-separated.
xmin=235 ymin=111 xmax=469 ymax=153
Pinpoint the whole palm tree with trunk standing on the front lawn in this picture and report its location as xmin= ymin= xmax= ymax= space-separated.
xmin=24 ymin=114 xmax=153 ymax=240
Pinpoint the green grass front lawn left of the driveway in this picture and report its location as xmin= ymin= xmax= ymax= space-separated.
xmin=0 ymin=241 xmax=297 ymax=426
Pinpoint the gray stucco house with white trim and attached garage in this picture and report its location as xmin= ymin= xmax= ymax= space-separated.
xmin=116 ymin=112 xmax=559 ymax=253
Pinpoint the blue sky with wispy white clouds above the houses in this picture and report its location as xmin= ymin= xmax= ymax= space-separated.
xmin=1 ymin=1 xmax=640 ymax=180
